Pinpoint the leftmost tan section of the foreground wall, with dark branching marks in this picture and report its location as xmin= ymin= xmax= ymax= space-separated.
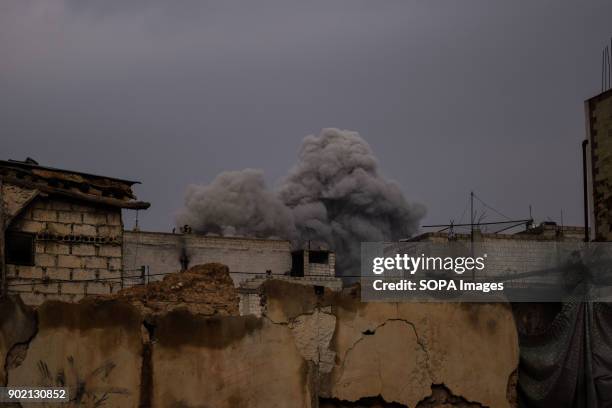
xmin=7 ymin=301 xmax=143 ymax=407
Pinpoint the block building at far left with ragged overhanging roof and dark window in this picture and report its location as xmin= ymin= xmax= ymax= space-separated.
xmin=0 ymin=159 xmax=150 ymax=304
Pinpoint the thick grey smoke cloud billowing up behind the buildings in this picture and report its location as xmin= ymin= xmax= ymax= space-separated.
xmin=177 ymin=129 xmax=425 ymax=274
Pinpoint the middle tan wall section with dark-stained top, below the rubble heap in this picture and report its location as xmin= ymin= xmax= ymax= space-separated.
xmin=152 ymin=313 xmax=311 ymax=408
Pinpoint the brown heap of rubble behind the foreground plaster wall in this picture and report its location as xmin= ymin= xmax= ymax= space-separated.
xmin=113 ymin=263 xmax=239 ymax=316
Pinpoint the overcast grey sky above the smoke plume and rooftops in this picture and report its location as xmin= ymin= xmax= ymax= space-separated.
xmin=0 ymin=0 xmax=612 ymax=230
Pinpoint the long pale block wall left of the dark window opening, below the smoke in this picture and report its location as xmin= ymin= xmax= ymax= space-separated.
xmin=123 ymin=231 xmax=291 ymax=285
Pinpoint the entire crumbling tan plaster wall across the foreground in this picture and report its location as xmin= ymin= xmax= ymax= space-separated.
xmin=0 ymin=281 xmax=518 ymax=408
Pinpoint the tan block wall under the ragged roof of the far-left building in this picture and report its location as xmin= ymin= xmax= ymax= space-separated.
xmin=7 ymin=198 xmax=123 ymax=305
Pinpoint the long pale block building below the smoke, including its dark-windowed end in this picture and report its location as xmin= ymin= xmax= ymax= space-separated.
xmin=123 ymin=228 xmax=342 ymax=315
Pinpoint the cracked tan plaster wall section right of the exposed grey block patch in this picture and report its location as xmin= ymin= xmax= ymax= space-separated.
xmin=329 ymin=302 xmax=518 ymax=407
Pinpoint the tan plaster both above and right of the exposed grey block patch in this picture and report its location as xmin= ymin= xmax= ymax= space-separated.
xmin=265 ymin=282 xmax=518 ymax=407
